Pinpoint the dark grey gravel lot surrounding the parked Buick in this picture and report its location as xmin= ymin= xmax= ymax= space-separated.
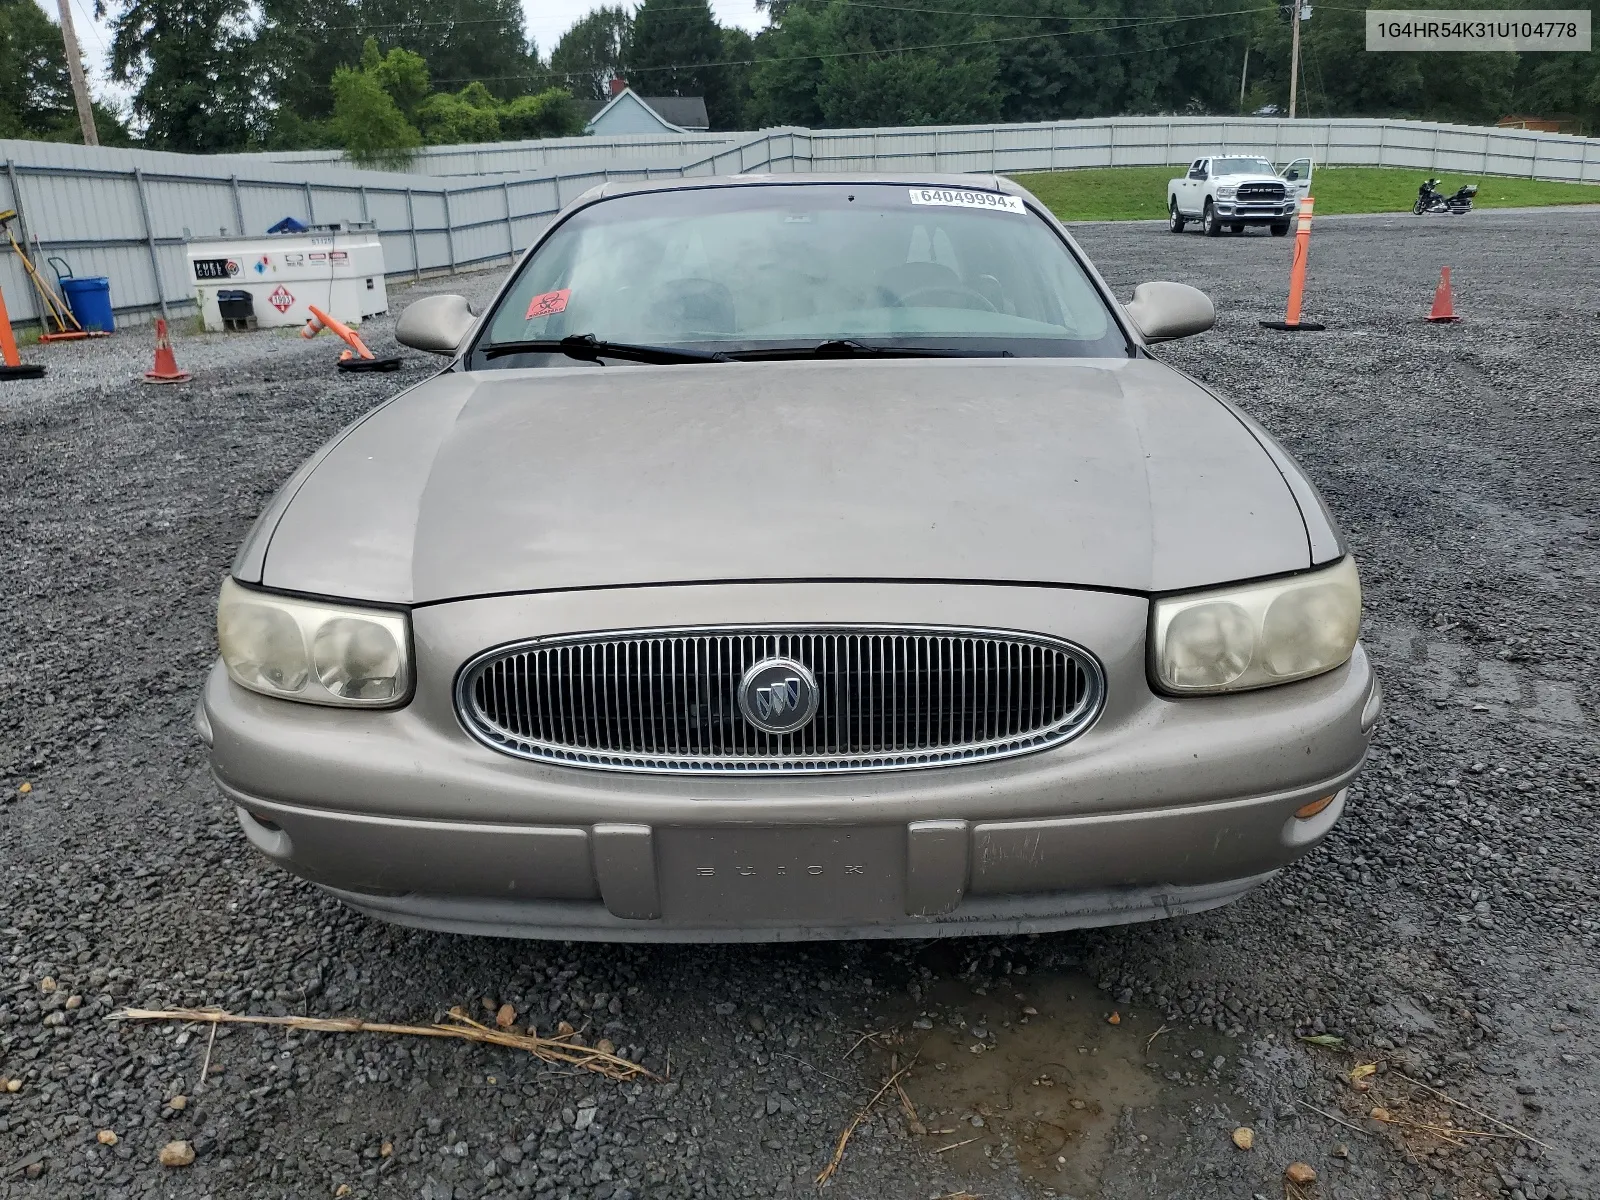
xmin=0 ymin=211 xmax=1600 ymax=1200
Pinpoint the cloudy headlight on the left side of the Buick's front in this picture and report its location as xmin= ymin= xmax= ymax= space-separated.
xmin=216 ymin=579 xmax=411 ymax=707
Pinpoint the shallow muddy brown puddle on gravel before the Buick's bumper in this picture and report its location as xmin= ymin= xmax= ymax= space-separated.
xmin=885 ymin=973 xmax=1240 ymax=1197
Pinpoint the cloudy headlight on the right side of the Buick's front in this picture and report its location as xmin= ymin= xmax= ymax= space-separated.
xmin=1150 ymin=557 xmax=1362 ymax=694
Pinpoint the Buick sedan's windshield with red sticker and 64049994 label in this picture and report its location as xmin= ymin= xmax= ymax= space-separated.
xmin=470 ymin=184 xmax=1130 ymax=370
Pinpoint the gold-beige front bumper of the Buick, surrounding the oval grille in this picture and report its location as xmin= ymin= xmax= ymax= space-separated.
xmin=197 ymin=584 xmax=1379 ymax=941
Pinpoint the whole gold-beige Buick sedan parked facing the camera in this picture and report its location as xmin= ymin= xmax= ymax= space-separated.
xmin=197 ymin=174 xmax=1379 ymax=941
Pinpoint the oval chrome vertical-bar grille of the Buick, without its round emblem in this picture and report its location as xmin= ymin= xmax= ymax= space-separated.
xmin=456 ymin=626 xmax=1104 ymax=774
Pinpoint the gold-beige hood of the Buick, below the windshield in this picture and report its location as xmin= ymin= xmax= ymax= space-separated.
xmin=256 ymin=358 xmax=1310 ymax=603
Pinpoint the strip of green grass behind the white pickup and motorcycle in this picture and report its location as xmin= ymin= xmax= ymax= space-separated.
xmin=1013 ymin=166 xmax=1600 ymax=221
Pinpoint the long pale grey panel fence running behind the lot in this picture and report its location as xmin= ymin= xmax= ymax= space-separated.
xmin=0 ymin=117 xmax=1600 ymax=329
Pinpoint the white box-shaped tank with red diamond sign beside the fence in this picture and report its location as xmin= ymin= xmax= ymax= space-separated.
xmin=187 ymin=222 xmax=389 ymax=331
